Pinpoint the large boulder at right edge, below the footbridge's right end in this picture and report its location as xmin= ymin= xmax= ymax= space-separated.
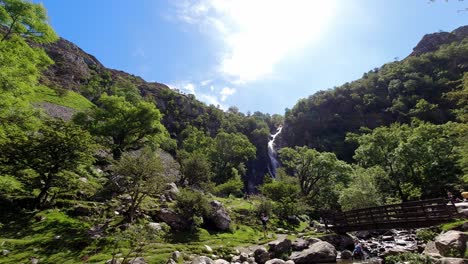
xmin=435 ymin=230 xmax=468 ymax=257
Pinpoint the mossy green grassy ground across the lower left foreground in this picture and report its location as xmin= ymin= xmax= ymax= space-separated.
xmin=0 ymin=198 xmax=318 ymax=263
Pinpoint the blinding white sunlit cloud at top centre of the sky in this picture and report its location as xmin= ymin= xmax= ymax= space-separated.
xmin=172 ymin=0 xmax=336 ymax=83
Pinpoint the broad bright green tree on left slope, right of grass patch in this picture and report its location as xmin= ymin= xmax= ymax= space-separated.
xmin=74 ymin=95 xmax=168 ymax=159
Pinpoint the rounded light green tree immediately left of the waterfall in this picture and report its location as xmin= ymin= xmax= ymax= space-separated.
xmin=209 ymin=132 xmax=255 ymax=184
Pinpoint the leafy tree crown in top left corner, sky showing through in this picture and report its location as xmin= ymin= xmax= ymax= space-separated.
xmin=0 ymin=0 xmax=57 ymax=43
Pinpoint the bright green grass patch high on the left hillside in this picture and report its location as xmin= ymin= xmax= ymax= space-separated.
xmin=26 ymin=85 xmax=93 ymax=111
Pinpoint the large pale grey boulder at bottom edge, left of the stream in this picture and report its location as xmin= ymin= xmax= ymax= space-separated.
xmin=289 ymin=241 xmax=337 ymax=264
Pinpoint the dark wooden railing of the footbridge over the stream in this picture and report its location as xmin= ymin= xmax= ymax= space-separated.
xmin=323 ymin=199 xmax=458 ymax=233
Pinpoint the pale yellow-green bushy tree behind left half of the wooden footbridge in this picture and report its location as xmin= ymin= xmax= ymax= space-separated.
xmin=339 ymin=167 xmax=385 ymax=211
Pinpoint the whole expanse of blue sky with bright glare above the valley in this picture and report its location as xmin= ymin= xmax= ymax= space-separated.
xmin=39 ymin=0 xmax=468 ymax=114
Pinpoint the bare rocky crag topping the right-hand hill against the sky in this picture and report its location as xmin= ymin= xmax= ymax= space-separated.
xmin=410 ymin=26 xmax=468 ymax=56
